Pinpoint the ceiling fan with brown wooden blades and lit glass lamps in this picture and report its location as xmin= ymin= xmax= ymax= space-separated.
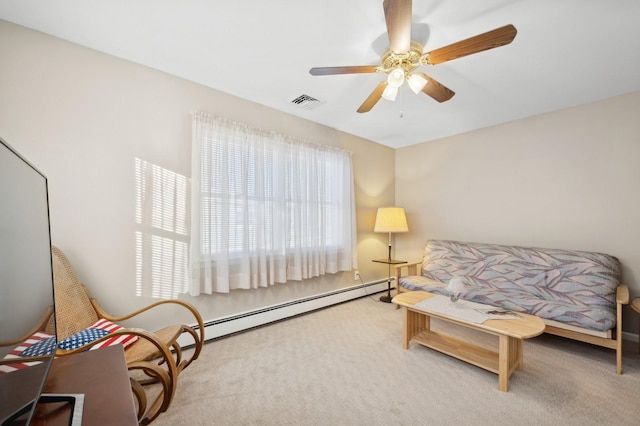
xmin=309 ymin=0 xmax=517 ymax=113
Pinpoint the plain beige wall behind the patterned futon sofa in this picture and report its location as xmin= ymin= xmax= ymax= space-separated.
xmin=396 ymin=93 xmax=640 ymax=332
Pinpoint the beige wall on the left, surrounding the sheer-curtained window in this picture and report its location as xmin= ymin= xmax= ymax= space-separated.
xmin=0 ymin=21 xmax=395 ymax=327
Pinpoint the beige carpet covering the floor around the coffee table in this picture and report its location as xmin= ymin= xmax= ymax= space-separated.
xmin=154 ymin=297 xmax=640 ymax=426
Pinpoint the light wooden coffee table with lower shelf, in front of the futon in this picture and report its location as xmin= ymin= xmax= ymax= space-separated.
xmin=393 ymin=291 xmax=544 ymax=392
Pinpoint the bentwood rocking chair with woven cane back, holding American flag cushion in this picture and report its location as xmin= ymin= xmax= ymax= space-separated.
xmin=45 ymin=247 xmax=204 ymax=424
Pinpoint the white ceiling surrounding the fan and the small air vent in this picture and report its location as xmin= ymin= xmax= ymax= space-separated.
xmin=0 ymin=0 xmax=640 ymax=147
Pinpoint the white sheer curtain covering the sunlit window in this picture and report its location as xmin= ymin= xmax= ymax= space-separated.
xmin=189 ymin=113 xmax=357 ymax=296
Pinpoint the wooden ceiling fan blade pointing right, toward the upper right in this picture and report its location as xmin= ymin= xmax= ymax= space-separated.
xmin=425 ymin=24 xmax=518 ymax=65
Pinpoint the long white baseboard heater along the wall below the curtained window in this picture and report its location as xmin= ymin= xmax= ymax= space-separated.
xmin=178 ymin=279 xmax=387 ymax=346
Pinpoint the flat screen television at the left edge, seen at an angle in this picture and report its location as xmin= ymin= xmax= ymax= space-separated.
xmin=0 ymin=138 xmax=56 ymax=425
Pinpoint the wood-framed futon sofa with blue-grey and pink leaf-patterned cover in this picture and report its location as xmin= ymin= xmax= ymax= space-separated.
xmin=396 ymin=240 xmax=629 ymax=374
